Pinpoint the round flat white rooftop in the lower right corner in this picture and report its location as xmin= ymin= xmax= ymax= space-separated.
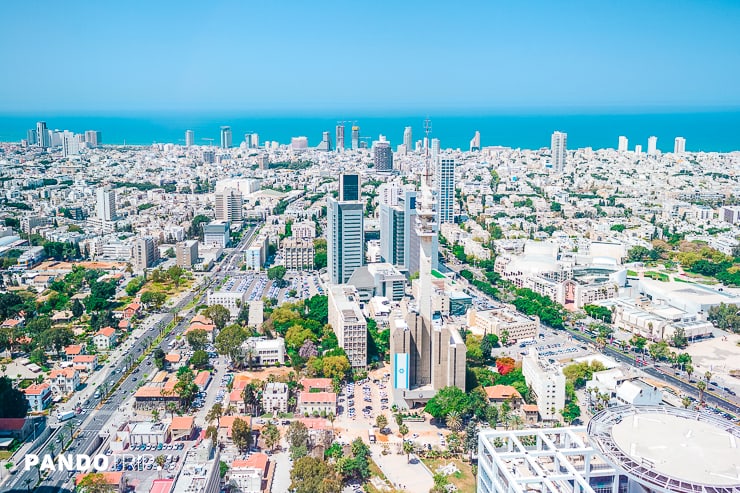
xmin=587 ymin=406 xmax=740 ymax=493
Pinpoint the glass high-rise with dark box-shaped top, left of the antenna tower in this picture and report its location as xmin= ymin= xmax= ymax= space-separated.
xmin=326 ymin=174 xmax=365 ymax=284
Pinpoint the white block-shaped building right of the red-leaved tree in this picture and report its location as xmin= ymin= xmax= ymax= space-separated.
xmin=522 ymin=349 xmax=565 ymax=421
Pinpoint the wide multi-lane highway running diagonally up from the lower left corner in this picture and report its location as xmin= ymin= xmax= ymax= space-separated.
xmin=5 ymin=227 xmax=256 ymax=493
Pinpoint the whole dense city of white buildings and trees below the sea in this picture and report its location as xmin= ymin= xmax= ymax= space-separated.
xmin=0 ymin=121 xmax=740 ymax=493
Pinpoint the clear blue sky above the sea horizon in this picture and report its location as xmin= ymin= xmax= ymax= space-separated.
xmin=0 ymin=0 xmax=740 ymax=115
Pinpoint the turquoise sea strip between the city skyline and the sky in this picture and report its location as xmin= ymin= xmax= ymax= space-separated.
xmin=0 ymin=111 xmax=740 ymax=152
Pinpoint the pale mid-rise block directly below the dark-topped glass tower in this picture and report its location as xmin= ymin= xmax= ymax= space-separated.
xmin=328 ymin=284 xmax=367 ymax=370
